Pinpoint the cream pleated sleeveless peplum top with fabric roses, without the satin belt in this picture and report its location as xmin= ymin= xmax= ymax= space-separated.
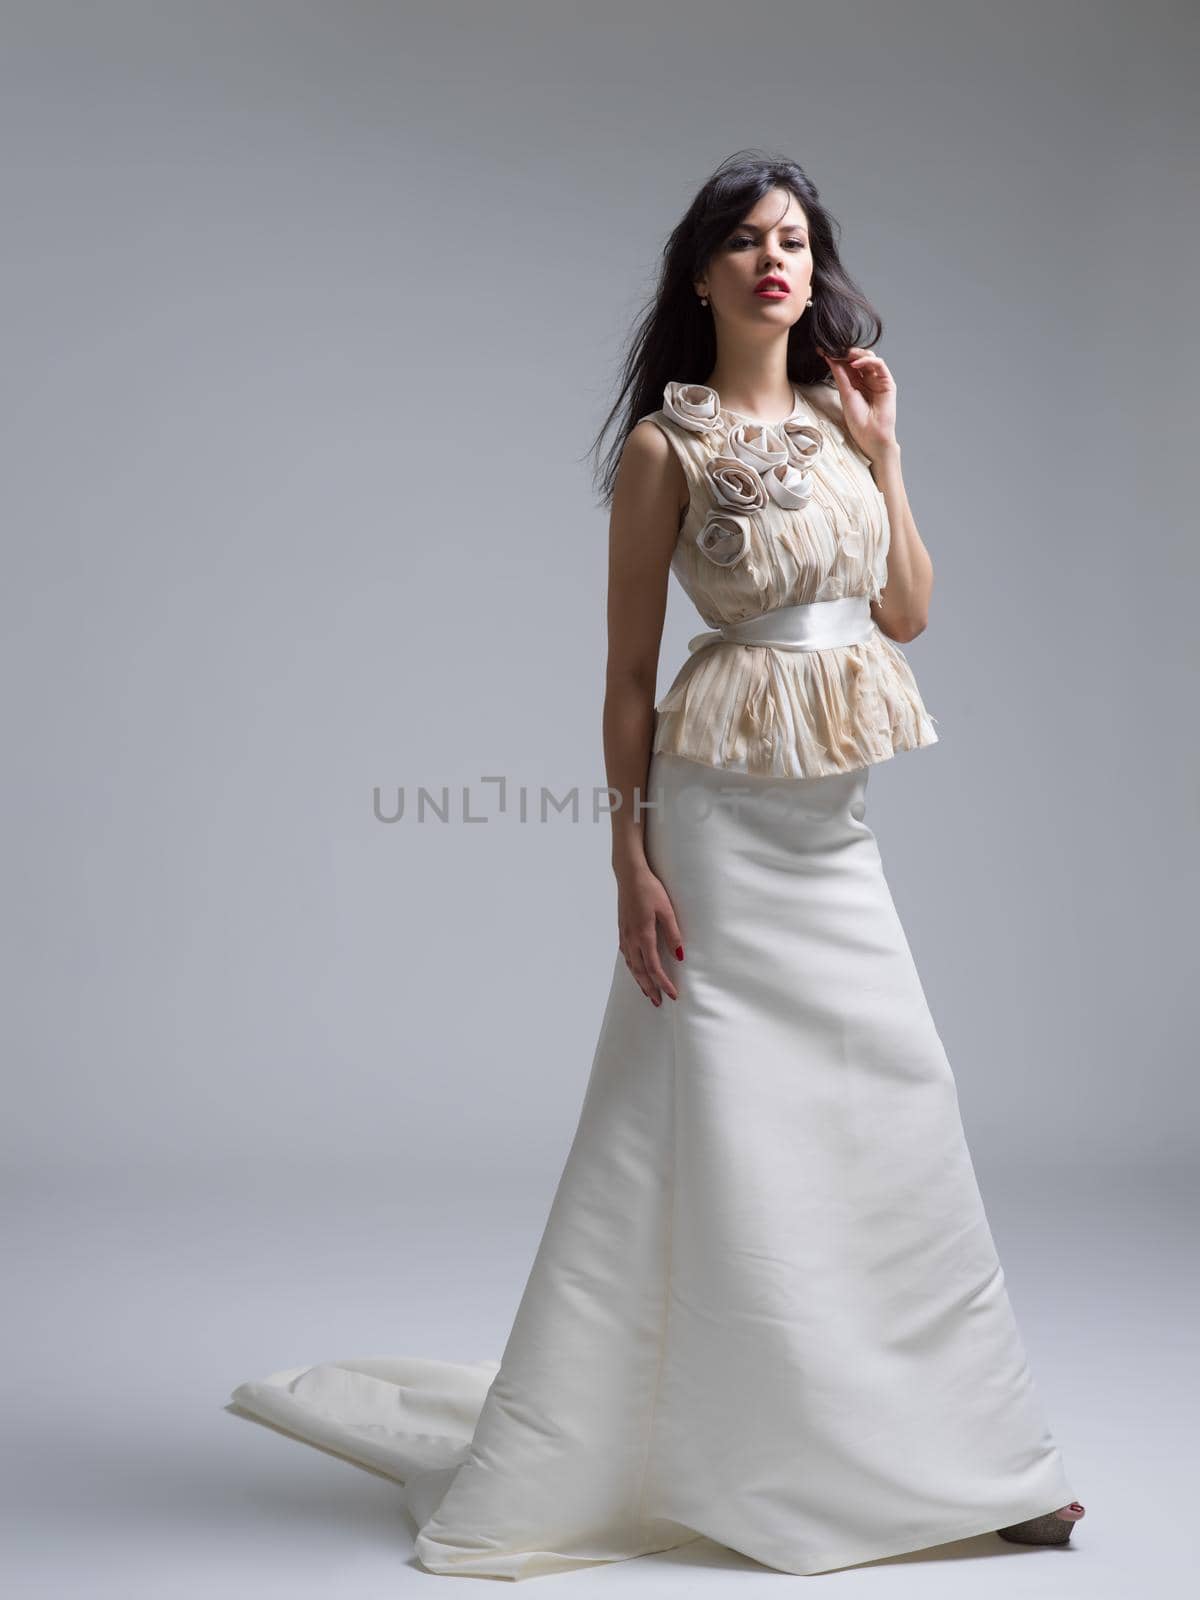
xmin=640 ymin=382 xmax=938 ymax=778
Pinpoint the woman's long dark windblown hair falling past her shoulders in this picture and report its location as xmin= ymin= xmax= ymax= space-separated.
xmin=589 ymin=150 xmax=883 ymax=504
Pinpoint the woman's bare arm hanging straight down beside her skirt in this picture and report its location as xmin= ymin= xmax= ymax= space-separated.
xmin=603 ymin=421 xmax=688 ymax=1005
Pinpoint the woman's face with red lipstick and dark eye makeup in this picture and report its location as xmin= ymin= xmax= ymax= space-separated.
xmin=696 ymin=189 xmax=813 ymax=328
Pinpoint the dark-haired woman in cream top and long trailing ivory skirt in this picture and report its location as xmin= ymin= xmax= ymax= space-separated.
xmin=234 ymin=157 xmax=1083 ymax=1578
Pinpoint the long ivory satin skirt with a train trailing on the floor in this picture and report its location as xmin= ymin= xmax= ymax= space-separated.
xmin=232 ymin=754 xmax=1075 ymax=1579
